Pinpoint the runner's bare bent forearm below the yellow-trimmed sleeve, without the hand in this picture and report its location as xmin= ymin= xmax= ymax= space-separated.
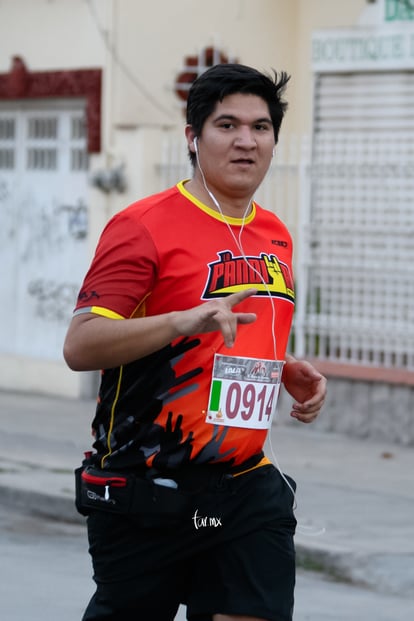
xmin=63 ymin=313 xmax=179 ymax=371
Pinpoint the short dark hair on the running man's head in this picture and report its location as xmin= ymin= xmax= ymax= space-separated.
xmin=187 ymin=63 xmax=290 ymax=164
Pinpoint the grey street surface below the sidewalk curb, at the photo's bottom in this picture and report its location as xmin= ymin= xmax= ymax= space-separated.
xmin=0 ymin=507 xmax=414 ymax=621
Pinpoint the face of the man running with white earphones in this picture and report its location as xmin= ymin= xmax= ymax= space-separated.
xmin=187 ymin=93 xmax=275 ymax=200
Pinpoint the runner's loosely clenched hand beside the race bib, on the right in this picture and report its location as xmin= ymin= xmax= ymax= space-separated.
xmin=283 ymin=356 xmax=326 ymax=423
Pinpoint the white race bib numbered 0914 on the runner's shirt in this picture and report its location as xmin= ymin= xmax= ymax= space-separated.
xmin=206 ymin=354 xmax=284 ymax=429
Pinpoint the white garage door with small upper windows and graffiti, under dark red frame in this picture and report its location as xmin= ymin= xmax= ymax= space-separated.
xmin=0 ymin=100 xmax=88 ymax=360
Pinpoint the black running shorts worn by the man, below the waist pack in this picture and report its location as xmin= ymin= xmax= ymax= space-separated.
xmin=83 ymin=465 xmax=296 ymax=621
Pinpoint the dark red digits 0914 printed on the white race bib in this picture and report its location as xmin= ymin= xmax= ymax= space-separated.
xmin=224 ymin=382 xmax=275 ymax=422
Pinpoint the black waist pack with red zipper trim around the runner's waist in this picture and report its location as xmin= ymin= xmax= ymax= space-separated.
xmin=75 ymin=465 xmax=190 ymax=522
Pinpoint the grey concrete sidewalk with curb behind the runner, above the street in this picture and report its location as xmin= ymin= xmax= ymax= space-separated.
xmin=0 ymin=392 xmax=414 ymax=598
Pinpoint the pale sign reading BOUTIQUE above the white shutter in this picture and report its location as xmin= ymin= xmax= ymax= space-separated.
xmin=312 ymin=26 xmax=414 ymax=72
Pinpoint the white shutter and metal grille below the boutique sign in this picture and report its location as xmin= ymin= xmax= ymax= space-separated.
xmin=299 ymin=73 xmax=414 ymax=369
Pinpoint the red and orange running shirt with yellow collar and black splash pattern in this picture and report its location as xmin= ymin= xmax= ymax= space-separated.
xmin=75 ymin=182 xmax=294 ymax=469
